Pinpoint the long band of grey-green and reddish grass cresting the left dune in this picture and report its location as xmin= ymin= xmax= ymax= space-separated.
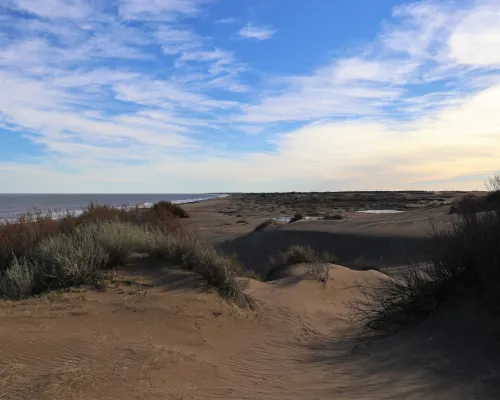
xmin=0 ymin=208 xmax=253 ymax=307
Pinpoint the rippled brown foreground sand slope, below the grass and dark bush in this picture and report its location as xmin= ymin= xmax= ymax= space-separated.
xmin=0 ymin=263 xmax=500 ymax=399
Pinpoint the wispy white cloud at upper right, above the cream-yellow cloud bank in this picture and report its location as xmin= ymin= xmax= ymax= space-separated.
xmin=239 ymin=1 xmax=500 ymax=123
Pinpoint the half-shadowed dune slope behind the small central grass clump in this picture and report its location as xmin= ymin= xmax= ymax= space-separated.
xmin=219 ymin=207 xmax=452 ymax=276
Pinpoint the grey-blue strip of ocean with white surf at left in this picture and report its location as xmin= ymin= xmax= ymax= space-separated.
xmin=0 ymin=193 xmax=227 ymax=221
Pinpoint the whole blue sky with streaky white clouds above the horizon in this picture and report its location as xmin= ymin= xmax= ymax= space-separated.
xmin=0 ymin=0 xmax=500 ymax=193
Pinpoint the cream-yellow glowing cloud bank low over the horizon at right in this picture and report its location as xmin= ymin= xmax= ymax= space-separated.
xmin=138 ymin=85 xmax=500 ymax=191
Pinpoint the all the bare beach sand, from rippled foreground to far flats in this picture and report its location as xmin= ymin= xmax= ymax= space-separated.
xmin=0 ymin=194 xmax=500 ymax=400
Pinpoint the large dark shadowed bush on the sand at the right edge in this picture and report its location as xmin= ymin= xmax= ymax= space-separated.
xmin=351 ymin=174 xmax=500 ymax=329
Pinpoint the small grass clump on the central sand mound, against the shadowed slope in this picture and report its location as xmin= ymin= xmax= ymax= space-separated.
xmin=265 ymin=245 xmax=337 ymax=280
